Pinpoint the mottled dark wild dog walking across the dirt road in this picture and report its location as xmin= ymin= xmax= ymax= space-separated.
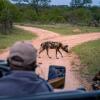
xmin=39 ymin=41 xmax=68 ymax=59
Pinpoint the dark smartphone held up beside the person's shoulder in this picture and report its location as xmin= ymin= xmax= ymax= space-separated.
xmin=48 ymin=65 xmax=66 ymax=89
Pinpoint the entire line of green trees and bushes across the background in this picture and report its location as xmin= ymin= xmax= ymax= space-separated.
xmin=0 ymin=0 xmax=100 ymax=31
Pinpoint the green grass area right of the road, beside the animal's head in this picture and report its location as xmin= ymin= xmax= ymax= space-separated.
xmin=72 ymin=39 xmax=100 ymax=76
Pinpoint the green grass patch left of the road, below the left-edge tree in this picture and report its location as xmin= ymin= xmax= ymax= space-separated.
xmin=0 ymin=28 xmax=36 ymax=51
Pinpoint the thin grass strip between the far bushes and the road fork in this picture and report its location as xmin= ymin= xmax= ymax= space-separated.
xmin=22 ymin=24 xmax=100 ymax=35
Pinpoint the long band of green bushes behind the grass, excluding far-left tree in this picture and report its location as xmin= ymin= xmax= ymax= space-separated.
xmin=12 ymin=5 xmax=100 ymax=26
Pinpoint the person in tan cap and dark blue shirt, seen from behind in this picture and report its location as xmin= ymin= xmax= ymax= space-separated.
xmin=0 ymin=41 xmax=53 ymax=96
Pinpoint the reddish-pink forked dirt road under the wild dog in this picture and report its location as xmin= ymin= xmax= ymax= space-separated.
xmin=0 ymin=25 xmax=100 ymax=90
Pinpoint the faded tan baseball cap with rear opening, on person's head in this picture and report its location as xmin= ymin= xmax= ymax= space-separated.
xmin=8 ymin=41 xmax=37 ymax=67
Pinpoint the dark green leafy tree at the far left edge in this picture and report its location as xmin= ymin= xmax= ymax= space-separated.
xmin=0 ymin=0 xmax=17 ymax=33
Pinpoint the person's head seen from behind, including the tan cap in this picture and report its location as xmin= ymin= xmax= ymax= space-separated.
xmin=7 ymin=41 xmax=37 ymax=71
